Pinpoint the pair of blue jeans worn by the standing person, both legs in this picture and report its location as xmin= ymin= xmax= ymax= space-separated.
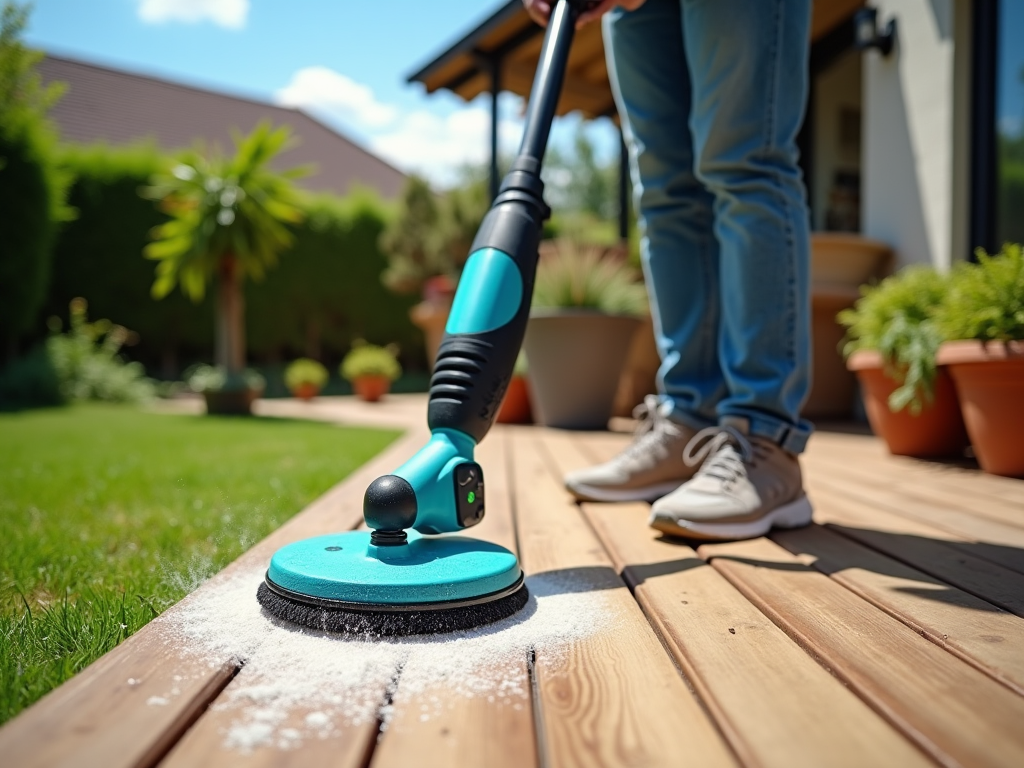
xmin=604 ymin=0 xmax=811 ymax=453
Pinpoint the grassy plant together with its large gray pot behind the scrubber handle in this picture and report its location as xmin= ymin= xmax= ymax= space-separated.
xmin=524 ymin=240 xmax=647 ymax=429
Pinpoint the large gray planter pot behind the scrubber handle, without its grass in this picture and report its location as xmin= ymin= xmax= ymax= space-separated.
xmin=523 ymin=309 xmax=641 ymax=429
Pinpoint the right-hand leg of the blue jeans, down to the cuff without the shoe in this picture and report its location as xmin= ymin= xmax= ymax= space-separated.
xmin=682 ymin=0 xmax=811 ymax=453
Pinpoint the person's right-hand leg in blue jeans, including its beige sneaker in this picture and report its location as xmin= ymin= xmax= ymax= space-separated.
xmin=651 ymin=0 xmax=812 ymax=539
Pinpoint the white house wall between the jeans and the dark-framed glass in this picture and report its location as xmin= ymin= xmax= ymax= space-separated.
xmin=862 ymin=0 xmax=970 ymax=268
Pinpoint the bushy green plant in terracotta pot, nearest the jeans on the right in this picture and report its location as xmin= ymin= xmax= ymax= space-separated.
xmin=837 ymin=266 xmax=967 ymax=457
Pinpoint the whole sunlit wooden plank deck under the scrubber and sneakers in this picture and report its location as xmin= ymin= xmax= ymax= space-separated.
xmin=0 ymin=397 xmax=1024 ymax=768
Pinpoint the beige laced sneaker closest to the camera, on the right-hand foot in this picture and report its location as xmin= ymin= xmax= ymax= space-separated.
xmin=650 ymin=419 xmax=813 ymax=539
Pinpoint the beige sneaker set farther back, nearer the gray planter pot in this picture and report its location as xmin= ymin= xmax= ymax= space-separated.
xmin=565 ymin=394 xmax=696 ymax=502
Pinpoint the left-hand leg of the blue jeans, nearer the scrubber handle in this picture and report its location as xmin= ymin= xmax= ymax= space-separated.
xmin=604 ymin=0 xmax=725 ymax=428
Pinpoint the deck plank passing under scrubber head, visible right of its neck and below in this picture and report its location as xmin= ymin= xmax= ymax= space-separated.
xmin=372 ymin=434 xmax=537 ymax=768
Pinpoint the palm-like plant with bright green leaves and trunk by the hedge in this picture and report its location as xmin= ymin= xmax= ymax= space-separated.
xmin=143 ymin=122 xmax=306 ymax=388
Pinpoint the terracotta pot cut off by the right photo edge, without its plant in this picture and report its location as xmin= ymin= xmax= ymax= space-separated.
xmin=938 ymin=341 xmax=1024 ymax=477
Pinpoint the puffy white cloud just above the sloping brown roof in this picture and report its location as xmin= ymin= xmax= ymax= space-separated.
xmin=275 ymin=67 xmax=398 ymax=129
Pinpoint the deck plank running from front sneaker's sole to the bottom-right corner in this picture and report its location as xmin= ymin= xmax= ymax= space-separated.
xmin=699 ymin=539 xmax=1024 ymax=766
